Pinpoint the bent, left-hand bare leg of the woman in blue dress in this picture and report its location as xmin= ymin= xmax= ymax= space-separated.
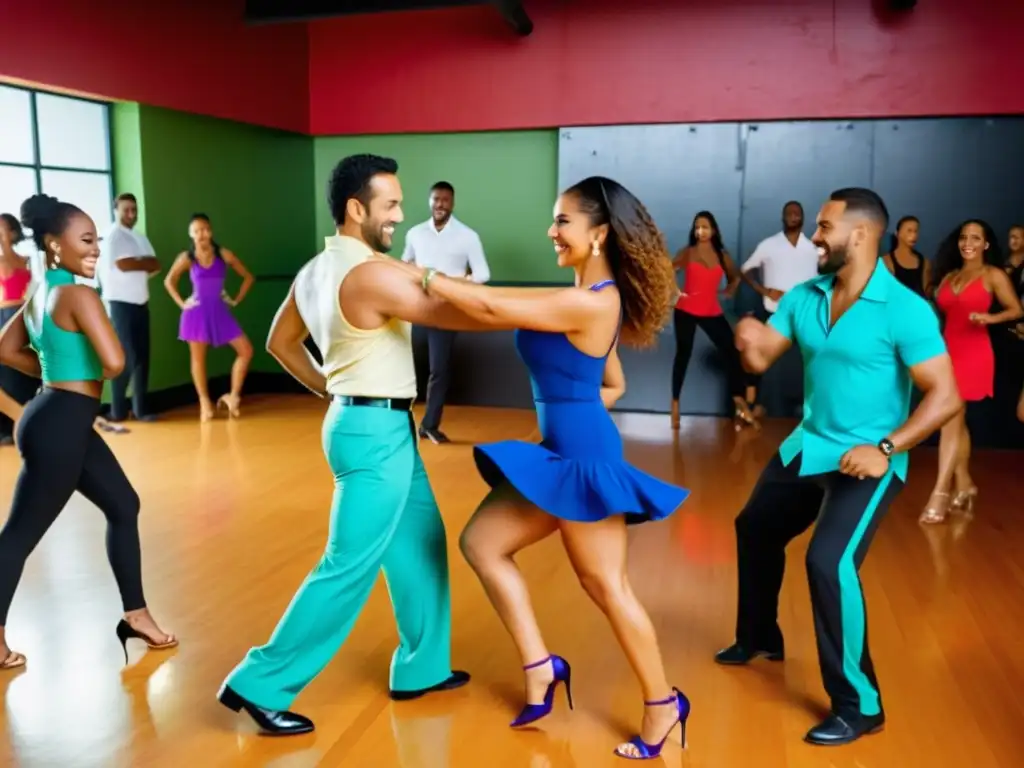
xmin=459 ymin=485 xmax=558 ymax=703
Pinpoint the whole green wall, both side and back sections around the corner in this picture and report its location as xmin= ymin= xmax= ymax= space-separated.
xmin=111 ymin=109 xmax=567 ymax=391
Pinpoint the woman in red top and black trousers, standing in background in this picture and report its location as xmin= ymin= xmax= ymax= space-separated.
xmin=672 ymin=211 xmax=758 ymax=429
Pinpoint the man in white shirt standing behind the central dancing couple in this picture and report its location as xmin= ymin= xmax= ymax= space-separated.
xmin=401 ymin=181 xmax=490 ymax=444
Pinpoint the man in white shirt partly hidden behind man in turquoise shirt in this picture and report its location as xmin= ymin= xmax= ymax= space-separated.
xmin=742 ymin=200 xmax=818 ymax=415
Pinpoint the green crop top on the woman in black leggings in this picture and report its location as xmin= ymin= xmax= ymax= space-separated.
xmin=25 ymin=268 xmax=103 ymax=384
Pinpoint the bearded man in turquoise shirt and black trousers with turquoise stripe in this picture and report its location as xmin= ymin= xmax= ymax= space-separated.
xmin=716 ymin=188 xmax=963 ymax=744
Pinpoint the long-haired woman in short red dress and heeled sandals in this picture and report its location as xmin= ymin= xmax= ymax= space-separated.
xmin=921 ymin=219 xmax=1024 ymax=522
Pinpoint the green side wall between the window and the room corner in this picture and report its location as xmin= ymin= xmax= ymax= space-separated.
xmin=112 ymin=103 xmax=315 ymax=391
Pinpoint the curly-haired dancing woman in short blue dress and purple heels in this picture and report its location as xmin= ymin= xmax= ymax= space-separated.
xmin=401 ymin=177 xmax=689 ymax=759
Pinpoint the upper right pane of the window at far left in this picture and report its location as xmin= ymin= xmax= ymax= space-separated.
xmin=36 ymin=93 xmax=111 ymax=171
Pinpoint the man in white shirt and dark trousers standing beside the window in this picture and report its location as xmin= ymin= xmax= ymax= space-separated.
xmin=98 ymin=193 xmax=160 ymax=422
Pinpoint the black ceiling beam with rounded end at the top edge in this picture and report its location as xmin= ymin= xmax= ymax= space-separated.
xmin=246 ymin=0 xmax=534 ymax=35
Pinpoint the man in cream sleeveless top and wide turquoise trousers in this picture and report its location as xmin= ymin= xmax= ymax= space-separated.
xmin=219 ymin=155 xmax=469 ymax=734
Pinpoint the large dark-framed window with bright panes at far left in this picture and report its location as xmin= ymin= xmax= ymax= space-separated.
xmin=0 ymin=84 xmax=114 ymax=250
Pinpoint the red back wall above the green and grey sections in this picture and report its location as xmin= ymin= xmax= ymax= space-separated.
xmin=309 ymin=0 xmax=1024 ymax=134
